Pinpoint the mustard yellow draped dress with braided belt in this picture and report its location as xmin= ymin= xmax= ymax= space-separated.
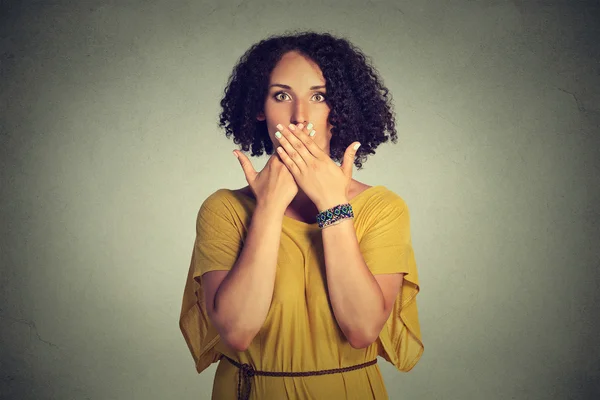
xmin=179 ymin=186 xmax=423 ymax=400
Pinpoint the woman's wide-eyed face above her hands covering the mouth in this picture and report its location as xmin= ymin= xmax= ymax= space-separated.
xmin=257 ymin=51 xmax=331 ymax=154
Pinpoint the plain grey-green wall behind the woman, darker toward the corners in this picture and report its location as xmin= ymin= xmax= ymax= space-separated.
xmin=0 ymin=0 xmax=600 ymax=399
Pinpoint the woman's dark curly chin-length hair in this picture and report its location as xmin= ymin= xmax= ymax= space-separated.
xmin=219 ymin=31 xmax=397 ymax=169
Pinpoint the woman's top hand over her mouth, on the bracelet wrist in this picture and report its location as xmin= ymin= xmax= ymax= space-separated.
xmin=275 ymin=124 xmax=360 ymax=211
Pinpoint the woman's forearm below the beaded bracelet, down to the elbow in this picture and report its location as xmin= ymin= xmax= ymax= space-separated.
xmin=322 ymin=220 xmax=385 ymax=348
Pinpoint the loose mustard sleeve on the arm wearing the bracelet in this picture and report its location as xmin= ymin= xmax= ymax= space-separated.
xmin=360 ymin=192 xmax=424 ymax=371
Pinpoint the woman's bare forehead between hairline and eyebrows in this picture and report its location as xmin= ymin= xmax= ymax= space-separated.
xmin=270 ymin=52 xmax=325 ymax=88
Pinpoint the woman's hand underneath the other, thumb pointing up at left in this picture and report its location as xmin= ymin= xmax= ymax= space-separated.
xmin=233 ymin=150 xmax=298 ymax=212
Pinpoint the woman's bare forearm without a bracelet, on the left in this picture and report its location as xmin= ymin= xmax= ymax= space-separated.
xmin=213 ymin=206 xmax=283 ymax=348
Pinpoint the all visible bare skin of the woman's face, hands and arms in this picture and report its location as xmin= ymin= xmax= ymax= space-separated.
xmin=202 ymin=52 xmax=404 ymax=351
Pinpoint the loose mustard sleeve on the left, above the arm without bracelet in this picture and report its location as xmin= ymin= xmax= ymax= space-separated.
xmin=179 ymin=191 xmax=243 ymax=373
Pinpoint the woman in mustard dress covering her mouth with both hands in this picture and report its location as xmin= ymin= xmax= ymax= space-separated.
xmin=180 ymin=32 xmax=423 ymax=399
